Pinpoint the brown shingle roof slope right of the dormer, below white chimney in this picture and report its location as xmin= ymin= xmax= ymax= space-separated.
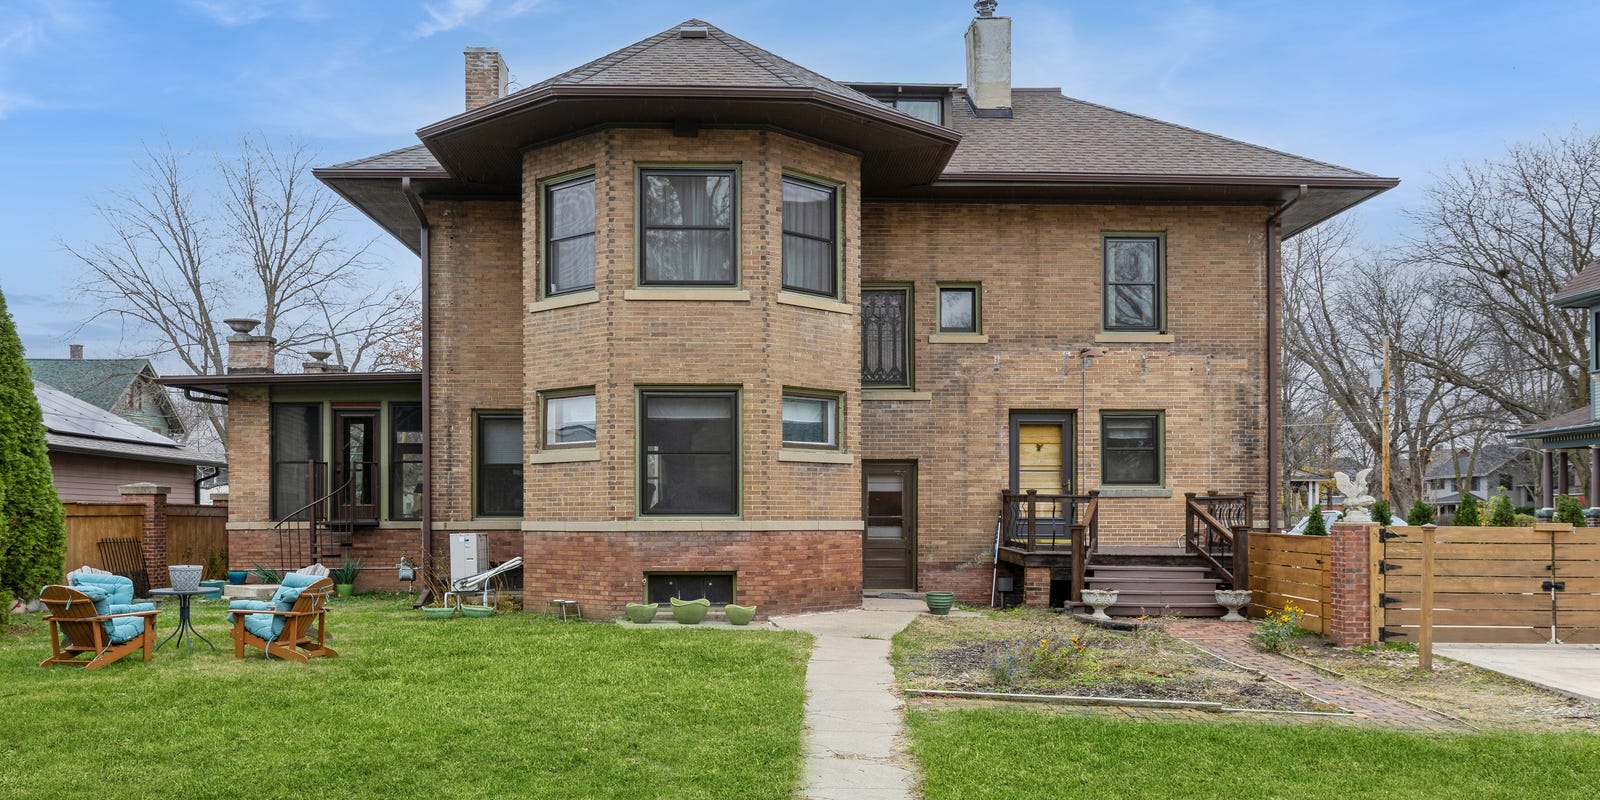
xmin=944 ymin=90 xmax=1374 ymax=179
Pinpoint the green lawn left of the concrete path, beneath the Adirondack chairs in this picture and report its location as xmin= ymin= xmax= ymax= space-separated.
xmin=0 ymin=595 xmax=810 ymax=798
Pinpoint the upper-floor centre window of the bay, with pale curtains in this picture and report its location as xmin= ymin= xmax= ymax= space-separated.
xmin=638 ymin=170 xmax=739 ymax=286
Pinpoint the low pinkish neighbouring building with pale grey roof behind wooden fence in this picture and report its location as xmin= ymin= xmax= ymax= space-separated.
xmin=34 ymin=381 xmax=224 ymax=502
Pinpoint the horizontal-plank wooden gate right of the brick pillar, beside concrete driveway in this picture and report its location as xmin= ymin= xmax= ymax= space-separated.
xmin=1371 ymin=523 xmax=1600 ymax=643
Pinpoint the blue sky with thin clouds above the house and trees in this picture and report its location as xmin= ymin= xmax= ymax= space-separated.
xmin=0 ymin=0 xmax=1600 ymax=366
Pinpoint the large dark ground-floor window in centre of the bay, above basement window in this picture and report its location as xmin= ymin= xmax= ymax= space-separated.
xmin=638 ymin=390 xmax=739 ymax=517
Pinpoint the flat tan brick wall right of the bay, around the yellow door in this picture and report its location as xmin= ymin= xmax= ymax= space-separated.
xmin=861 ymin=203 xmax=1269 ymax=597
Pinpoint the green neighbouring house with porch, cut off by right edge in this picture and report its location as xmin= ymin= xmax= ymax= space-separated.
xmin=1506 ymin=261 xmax=1600 ymax=509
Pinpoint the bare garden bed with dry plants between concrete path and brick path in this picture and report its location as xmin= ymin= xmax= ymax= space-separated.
xmin=894 ymin=610 xmax=1339 ymax=712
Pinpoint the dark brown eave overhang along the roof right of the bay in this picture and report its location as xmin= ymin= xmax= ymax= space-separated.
xmin=870 ymin=173 xmax=1400 ymax=238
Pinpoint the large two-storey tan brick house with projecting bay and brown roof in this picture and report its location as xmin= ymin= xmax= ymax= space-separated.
xmin=156 ymin=7 xmax=1397 ymax=616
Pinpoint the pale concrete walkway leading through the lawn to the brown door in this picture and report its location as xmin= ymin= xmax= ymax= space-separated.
xmin=773 ymin=597 xmax=926 ymax=800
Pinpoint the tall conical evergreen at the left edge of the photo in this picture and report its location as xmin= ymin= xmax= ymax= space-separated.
xmin=0 ymin=286 xmax=67 ymax=626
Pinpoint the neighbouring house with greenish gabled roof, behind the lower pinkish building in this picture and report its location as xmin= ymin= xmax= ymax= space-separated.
xmin=26 ymin=344 xmax=187 ymax=440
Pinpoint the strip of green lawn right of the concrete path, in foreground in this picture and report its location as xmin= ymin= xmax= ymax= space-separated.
xmin=907 ymin=709 xmax=1600 ymax=800
